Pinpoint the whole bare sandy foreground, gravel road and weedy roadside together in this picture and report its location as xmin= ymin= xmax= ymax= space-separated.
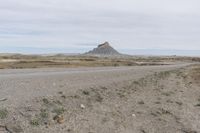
xmin=0 ymin=64 xmax=200 ymax=133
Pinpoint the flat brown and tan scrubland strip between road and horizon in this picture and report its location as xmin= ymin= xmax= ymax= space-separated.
xmin=0 ymin=54 xmax=200 ymax=69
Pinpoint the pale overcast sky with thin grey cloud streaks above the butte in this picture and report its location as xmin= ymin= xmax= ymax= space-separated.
xmin=0 ymin=0 xmax=200 ymax=53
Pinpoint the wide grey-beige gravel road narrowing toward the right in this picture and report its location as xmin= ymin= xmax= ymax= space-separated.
xmin=0 ymin=64 xmax=189 ymax=106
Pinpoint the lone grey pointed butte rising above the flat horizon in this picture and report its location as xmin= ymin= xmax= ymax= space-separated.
xmin=86 ymin=42 xmax=121 ymax=56
